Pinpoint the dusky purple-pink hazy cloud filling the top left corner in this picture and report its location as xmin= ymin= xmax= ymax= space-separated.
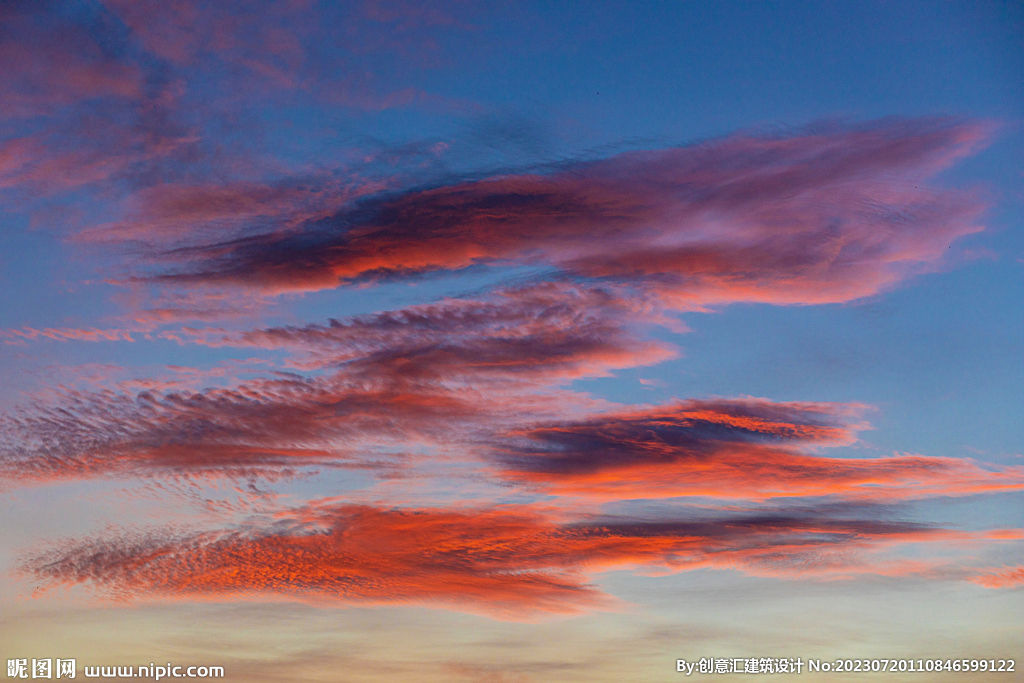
xmin=0 ymin=1 xmax=196 ymax=200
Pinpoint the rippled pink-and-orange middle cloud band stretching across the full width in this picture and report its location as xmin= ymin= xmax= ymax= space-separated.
xmin=9 ymin=283 xmax=1024 ymax=507
